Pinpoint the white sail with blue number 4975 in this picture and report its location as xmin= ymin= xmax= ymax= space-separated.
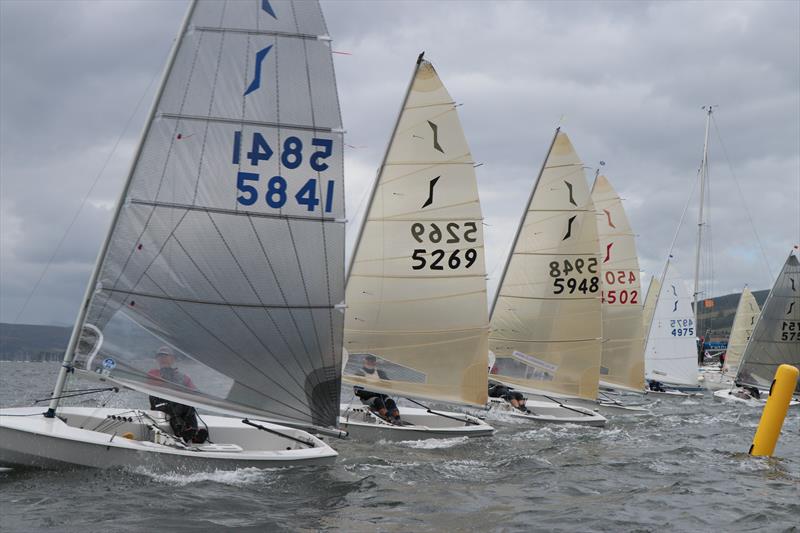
xmin=645 ymin=261 xmax=697 ymax=386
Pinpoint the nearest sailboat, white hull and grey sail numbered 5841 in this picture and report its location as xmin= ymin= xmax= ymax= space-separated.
xmin=0 ymin=0 xmax=344 ymax=470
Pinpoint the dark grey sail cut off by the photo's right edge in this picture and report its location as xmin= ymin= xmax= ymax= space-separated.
xmin=736 ymin=254 xmax=800 ymax=393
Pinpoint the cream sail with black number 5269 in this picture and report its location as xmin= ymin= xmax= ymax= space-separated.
xmin=344 ymin=61 xmax=489 ymax=405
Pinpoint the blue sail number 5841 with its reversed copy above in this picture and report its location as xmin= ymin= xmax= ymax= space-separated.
xmin=231 ymin=131 xmax=336 ymax=213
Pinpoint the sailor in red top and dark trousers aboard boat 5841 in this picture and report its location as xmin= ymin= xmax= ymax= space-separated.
xmin=147 ymin=346 xmax=208 ymax=444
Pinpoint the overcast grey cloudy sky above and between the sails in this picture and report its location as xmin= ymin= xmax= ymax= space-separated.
xmin=0 ymin=0 xmax=800 ymax=325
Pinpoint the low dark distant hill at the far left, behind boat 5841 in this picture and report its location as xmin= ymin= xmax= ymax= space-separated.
xmin=0 ymin=322 xmax=72 ymax=361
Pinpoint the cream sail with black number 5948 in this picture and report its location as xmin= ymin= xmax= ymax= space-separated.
xmin=489 ymin=131 xmax=601 ymax=400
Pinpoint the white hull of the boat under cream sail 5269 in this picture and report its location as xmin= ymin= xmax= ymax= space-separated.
xmin=339 ymin=404 xmax=494 ymax=441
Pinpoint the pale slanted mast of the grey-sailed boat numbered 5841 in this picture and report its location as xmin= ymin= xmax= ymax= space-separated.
xmin=44 ymin=0 xmax=197 ymax=418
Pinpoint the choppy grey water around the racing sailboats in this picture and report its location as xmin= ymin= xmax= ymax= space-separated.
xmin=0 ymin=362 xmax=800 ymax=533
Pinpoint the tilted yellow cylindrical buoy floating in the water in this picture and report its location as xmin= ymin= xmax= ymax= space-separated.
xmin=750 ymin=365 xmax=800 ymax=456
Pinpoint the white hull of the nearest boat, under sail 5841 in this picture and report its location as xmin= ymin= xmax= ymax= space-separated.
xmin=0 ymin=407 xmax=338 ymax=472
